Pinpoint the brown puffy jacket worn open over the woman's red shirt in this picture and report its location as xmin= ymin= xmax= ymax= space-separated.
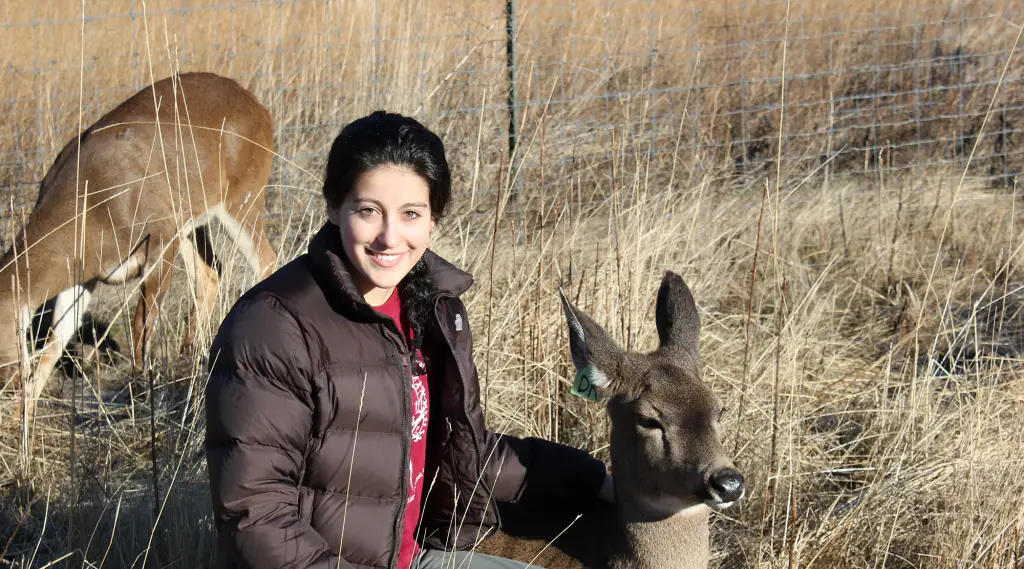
xmin=206 ymin=222 xmax=605 ymax=569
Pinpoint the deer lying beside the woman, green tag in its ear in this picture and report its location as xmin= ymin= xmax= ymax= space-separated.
xmin=476 ymin=272 xmax=744 ymax=569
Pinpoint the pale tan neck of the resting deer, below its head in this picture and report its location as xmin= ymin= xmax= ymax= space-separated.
xmin=608 ymin=489 xmax=711 ymax=569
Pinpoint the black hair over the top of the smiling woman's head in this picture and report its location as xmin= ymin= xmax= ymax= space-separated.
xmin=324 ymin=111 xmax=452 ymax=221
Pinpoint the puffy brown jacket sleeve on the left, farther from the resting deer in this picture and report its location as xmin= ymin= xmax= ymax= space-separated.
xmin=206 ymin=297 xmax=350 ymax=569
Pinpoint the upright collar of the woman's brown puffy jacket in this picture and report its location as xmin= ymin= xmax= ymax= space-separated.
xmin=307 ymin=221 xmax=473 ymax=313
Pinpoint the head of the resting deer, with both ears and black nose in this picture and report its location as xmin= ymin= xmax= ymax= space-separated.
xmin=561 ymin=272 xmax=744 ymax=519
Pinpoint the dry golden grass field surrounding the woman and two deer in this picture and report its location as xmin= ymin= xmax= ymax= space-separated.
xmin=0 ymin=0 xmax=1024 ymax=569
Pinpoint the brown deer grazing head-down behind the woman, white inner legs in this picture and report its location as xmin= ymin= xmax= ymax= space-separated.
xmin=0 ymin=73 xmax=276 ymax=420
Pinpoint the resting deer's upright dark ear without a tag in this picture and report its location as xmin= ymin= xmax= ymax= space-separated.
xmin=654 ymin=271 xmax=700 ymax=364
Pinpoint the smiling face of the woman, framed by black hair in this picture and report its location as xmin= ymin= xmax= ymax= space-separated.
xmin=328 ymin=166 xmax=434 ymax=306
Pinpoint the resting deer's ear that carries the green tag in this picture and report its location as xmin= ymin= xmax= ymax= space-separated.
xmin=558 ymin=289 xmax=625 ymax=390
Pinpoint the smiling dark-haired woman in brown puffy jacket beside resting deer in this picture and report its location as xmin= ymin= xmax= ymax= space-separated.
xmin=206 ymin=112 xmax=610 ymax=569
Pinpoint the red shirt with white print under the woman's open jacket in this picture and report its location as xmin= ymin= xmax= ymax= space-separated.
xmin=376 ymin=289 xmax=430 ymax=569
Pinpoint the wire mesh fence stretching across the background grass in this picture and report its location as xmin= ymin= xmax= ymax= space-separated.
xmin=0 ymin=0 xmax=1024 ymax=242
